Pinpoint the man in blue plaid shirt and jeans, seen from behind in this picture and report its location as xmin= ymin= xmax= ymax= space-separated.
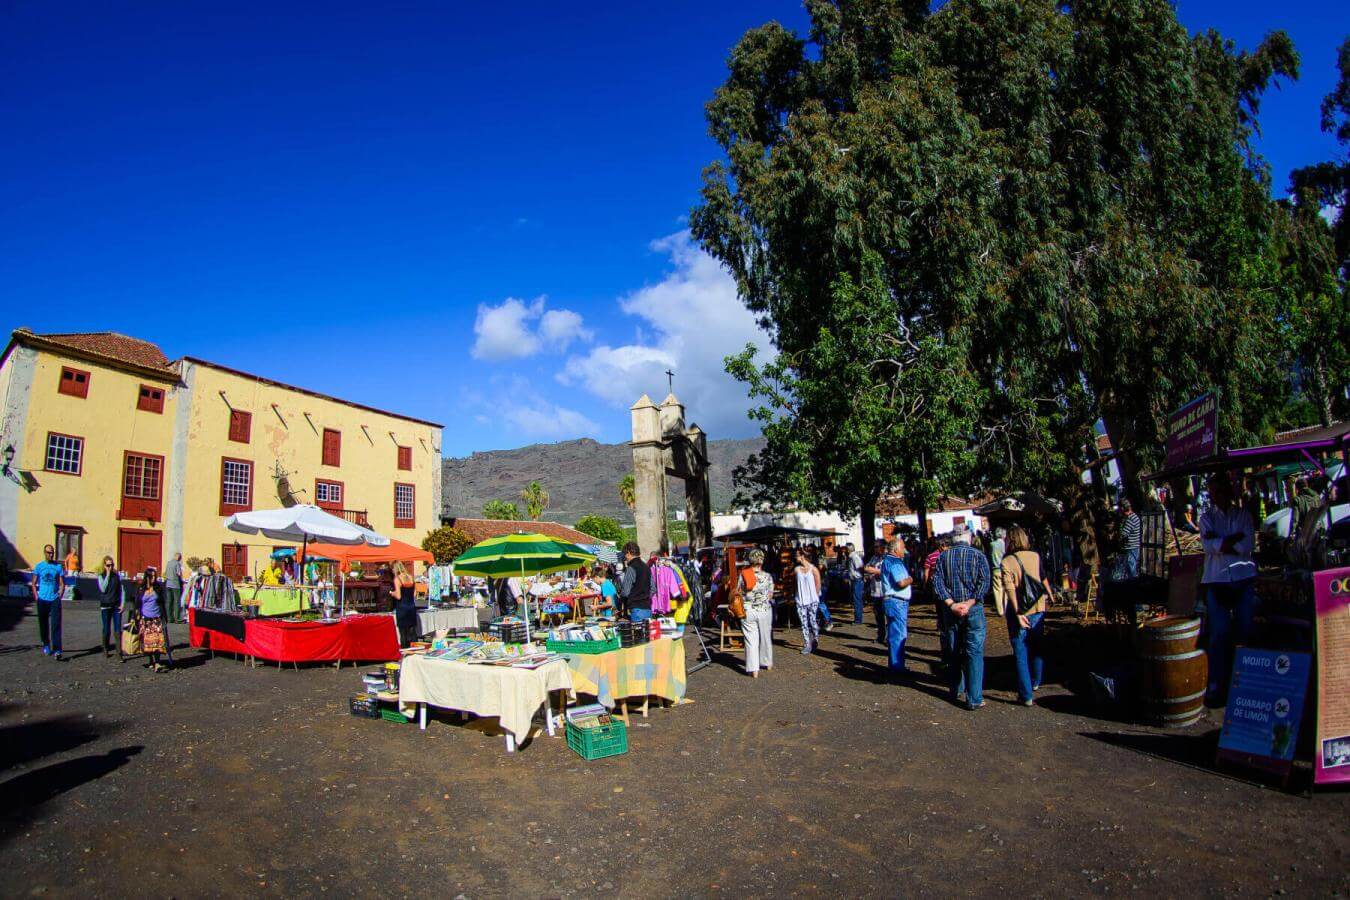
xmin=933 ymin=525 xmax=990 ymax=710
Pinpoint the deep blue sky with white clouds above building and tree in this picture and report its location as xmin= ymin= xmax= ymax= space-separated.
xmin=0 ymin=0 xmax=1350 ymax=455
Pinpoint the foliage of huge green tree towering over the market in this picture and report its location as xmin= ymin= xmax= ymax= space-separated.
xmin=693 ymin=0 xmax=1297 ymax=555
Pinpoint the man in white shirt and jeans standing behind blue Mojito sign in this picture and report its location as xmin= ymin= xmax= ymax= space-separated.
xmin=1200 ymin=472 xmax=1257 ymax=706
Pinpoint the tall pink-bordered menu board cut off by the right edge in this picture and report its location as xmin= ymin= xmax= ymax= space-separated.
xmin=1312 ymin=568 xmax=1350 ymax=784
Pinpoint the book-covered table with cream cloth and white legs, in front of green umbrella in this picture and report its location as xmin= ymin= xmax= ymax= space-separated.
xmin=398 ymin=650 xmax=572 ymax=753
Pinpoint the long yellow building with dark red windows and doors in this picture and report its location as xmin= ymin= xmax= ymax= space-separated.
xmin=0 ymin=329 xmax=441 ymax=578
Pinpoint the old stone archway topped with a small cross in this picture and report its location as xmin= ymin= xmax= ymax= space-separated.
xmin=629 ymin=393 xmax=713 ymax=553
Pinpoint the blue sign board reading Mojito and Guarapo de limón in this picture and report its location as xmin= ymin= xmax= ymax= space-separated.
xmin=1219 ymin=646 xmax=1312 ymax=775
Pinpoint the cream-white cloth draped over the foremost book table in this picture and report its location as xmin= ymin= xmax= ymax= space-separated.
xmin=398 ymin=654 xmax=572 ymax=741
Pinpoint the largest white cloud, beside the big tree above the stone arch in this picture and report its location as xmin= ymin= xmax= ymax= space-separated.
xmin=559 ymin=232 xmax=770 ymax=437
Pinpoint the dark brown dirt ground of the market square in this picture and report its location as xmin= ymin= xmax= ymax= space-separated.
xmin=0 ymin=602 xmax=1350 ymax=897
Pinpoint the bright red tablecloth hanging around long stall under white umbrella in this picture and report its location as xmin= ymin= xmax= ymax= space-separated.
xmin=188 ymin=610 xmax=398 ymax=663
